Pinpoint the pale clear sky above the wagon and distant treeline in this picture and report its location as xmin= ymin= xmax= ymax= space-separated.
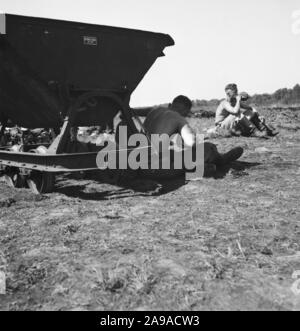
xmin=0 ymin=0 xmax=300 ymax=107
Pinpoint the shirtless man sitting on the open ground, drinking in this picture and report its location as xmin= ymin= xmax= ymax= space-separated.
xmin=215 ymin=84 xmax=278 ymax=137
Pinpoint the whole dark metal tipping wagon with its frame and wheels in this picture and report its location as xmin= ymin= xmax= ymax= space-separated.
xmin=0 ymin=14 xmax=174 ymax=193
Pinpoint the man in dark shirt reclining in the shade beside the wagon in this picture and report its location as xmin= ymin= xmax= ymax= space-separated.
xmin=134 ymin=95 xmax=243 ymax=174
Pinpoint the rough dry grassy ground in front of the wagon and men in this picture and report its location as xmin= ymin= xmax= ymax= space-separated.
xmin=0 ymin=110 xmax=300 ymax=310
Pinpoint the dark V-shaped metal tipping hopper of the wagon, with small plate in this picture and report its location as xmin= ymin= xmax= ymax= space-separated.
xmin=0 ymin=14 xmax=174 ymax=128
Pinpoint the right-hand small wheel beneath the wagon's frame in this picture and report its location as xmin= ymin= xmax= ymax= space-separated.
xmin=27 ymin=171 xmax=55 ymax=194
